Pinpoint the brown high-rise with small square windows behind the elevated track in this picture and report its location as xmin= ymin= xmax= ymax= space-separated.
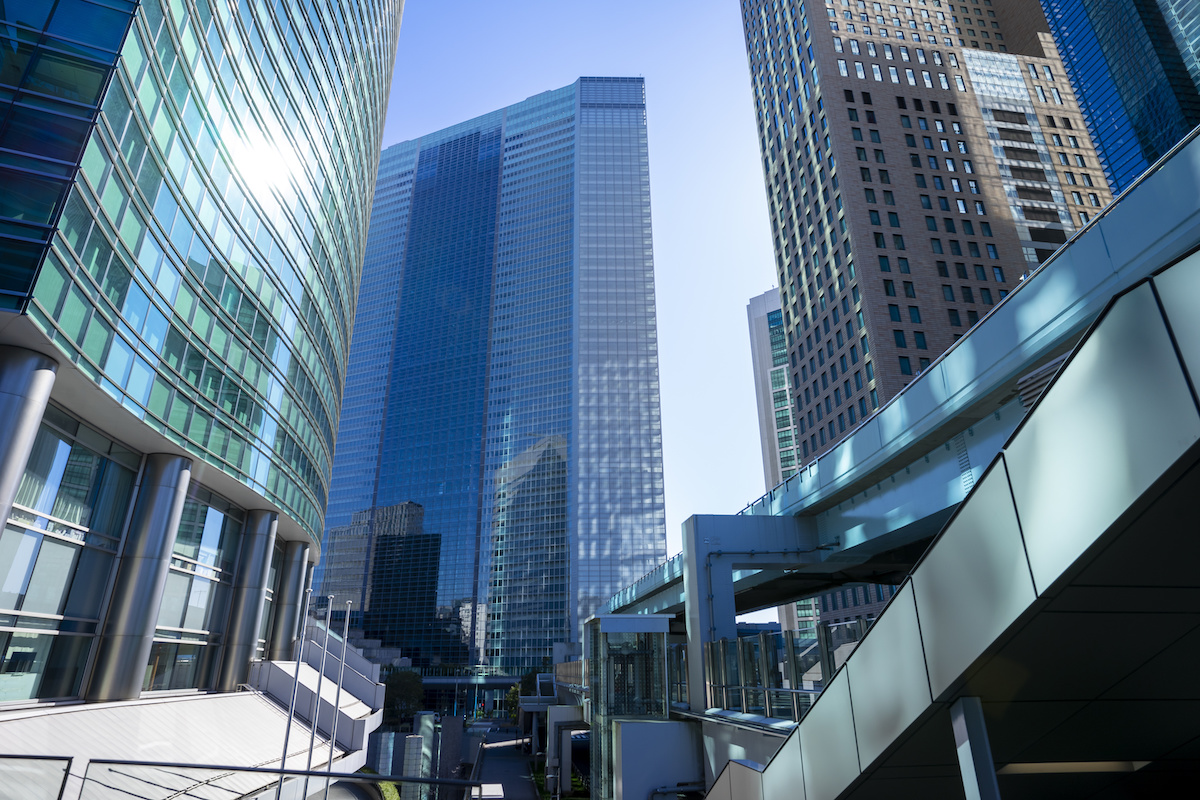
xmin=742 ymin=0 xmax=1110 ymax=464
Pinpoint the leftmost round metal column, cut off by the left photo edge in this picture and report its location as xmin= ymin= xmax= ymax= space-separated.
xmin=0 ymin=347 xmax=59 ymax=522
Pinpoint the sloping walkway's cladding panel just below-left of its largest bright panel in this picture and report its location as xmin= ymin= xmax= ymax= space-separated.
xmin=907 ymin=457 xmax=1037 ymax=698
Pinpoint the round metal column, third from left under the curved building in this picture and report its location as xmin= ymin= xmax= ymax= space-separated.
xmin=217 ymin=511 xmax=280 ymax=692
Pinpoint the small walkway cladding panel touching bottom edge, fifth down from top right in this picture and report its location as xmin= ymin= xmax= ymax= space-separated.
xmin=799 ymin=670 xmax=862 ymax=800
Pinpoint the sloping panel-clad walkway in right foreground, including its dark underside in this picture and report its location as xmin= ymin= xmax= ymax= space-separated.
xmin=708 ymin=241 xmax=1200 ymax=800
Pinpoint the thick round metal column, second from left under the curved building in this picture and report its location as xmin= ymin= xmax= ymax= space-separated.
xmin=85 ymin=453 xmax=192 ymax=702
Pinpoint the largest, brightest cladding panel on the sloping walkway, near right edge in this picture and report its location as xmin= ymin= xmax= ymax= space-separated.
xmin=1004 ymin=285 xmax=1200 ymax=594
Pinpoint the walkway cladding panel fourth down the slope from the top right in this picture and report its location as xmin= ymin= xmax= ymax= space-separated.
xmin=846 ymin=582 xmax=931 ymax=765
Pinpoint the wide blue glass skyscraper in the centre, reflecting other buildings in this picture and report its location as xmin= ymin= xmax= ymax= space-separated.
xmin=323 ymin=78 xmax=666 ymax=674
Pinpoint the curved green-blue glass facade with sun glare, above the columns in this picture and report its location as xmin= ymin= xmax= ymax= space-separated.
xmin=0 ymin=0 xmax=398 ymax=540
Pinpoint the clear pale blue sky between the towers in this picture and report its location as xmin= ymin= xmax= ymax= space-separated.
xmin=384 ymin=0 xmax=775 ymax=553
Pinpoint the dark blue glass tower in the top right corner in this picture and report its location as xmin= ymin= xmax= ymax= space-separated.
xmin=1042 ymin=0 xmax=1200 ymax=192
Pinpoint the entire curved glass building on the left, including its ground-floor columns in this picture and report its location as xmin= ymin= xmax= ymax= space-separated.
xmin=0 ymin=0 xmax=402 ymax=703
